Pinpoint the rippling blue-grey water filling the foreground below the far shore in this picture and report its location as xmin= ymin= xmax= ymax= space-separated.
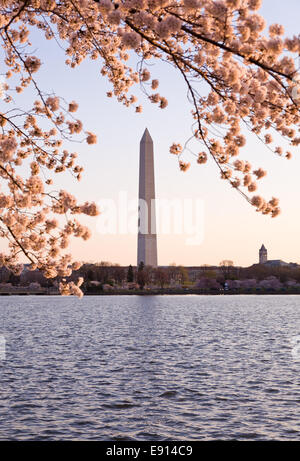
xmin=0 ymin=296 xmax=300 ymax=441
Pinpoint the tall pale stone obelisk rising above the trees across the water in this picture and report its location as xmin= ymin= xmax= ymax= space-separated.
xmin=137 ymin=128 xmax=157 ymax=267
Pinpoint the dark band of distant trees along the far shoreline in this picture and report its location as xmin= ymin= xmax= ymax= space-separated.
xmin=0 ymin=262 xmax=300 ymax=290
